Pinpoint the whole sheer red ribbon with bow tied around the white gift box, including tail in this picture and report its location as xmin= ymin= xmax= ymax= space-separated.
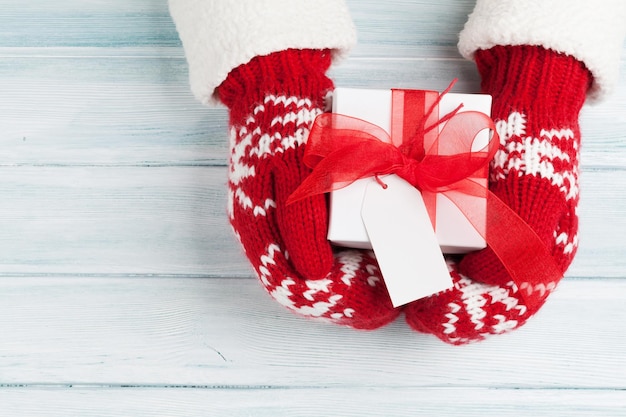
xmin=287 ymin=88 xmax=563 ymax=307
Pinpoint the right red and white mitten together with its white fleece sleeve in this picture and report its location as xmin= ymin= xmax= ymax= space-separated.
xmin=405 ymin=0 xmax=626 ymax=344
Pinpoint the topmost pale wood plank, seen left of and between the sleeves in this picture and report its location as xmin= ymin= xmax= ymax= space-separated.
xmin=0 ymin=0 xmax=473 ymax=57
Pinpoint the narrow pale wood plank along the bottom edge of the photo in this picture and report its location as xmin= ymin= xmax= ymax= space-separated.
xmin=0 ymin=387 xmax=626 ymax=417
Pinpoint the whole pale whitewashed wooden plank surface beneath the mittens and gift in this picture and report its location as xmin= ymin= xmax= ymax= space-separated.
xmin=0 ymin=0 xmax=626 ymax=416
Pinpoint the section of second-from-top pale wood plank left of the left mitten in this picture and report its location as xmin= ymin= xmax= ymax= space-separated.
xmin=0 ymin=49 xmax=228 ymax=165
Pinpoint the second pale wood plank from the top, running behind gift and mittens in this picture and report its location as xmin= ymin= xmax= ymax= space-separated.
xmin=0 ymin=48 xmax=626 ymax=169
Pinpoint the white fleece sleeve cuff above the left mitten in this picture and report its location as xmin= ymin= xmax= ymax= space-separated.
xmin=169 ymin=0 xmax=356 ymax=104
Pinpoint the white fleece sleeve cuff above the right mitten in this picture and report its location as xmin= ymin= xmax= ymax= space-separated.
xmin=459 ymin=0 xmax=626 ymax=100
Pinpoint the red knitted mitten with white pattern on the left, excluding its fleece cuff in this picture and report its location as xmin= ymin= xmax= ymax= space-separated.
xmin=217 ymin=50 xmax=399 ymax=329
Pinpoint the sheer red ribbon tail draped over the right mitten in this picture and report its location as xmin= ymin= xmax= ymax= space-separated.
xmin=480 ymin=192 xmax=563 ymax=308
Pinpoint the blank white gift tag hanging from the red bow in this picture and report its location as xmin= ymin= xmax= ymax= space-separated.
xmin=361 ymin=175 xmax=452 ymax=307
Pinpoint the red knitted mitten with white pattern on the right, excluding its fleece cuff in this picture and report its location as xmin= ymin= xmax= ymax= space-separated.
xmin=405 ymin=46 xmax=591 ymax=344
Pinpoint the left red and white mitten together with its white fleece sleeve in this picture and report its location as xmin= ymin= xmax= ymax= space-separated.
xmin=170 ymin=0 xmax=399 ymax=329
